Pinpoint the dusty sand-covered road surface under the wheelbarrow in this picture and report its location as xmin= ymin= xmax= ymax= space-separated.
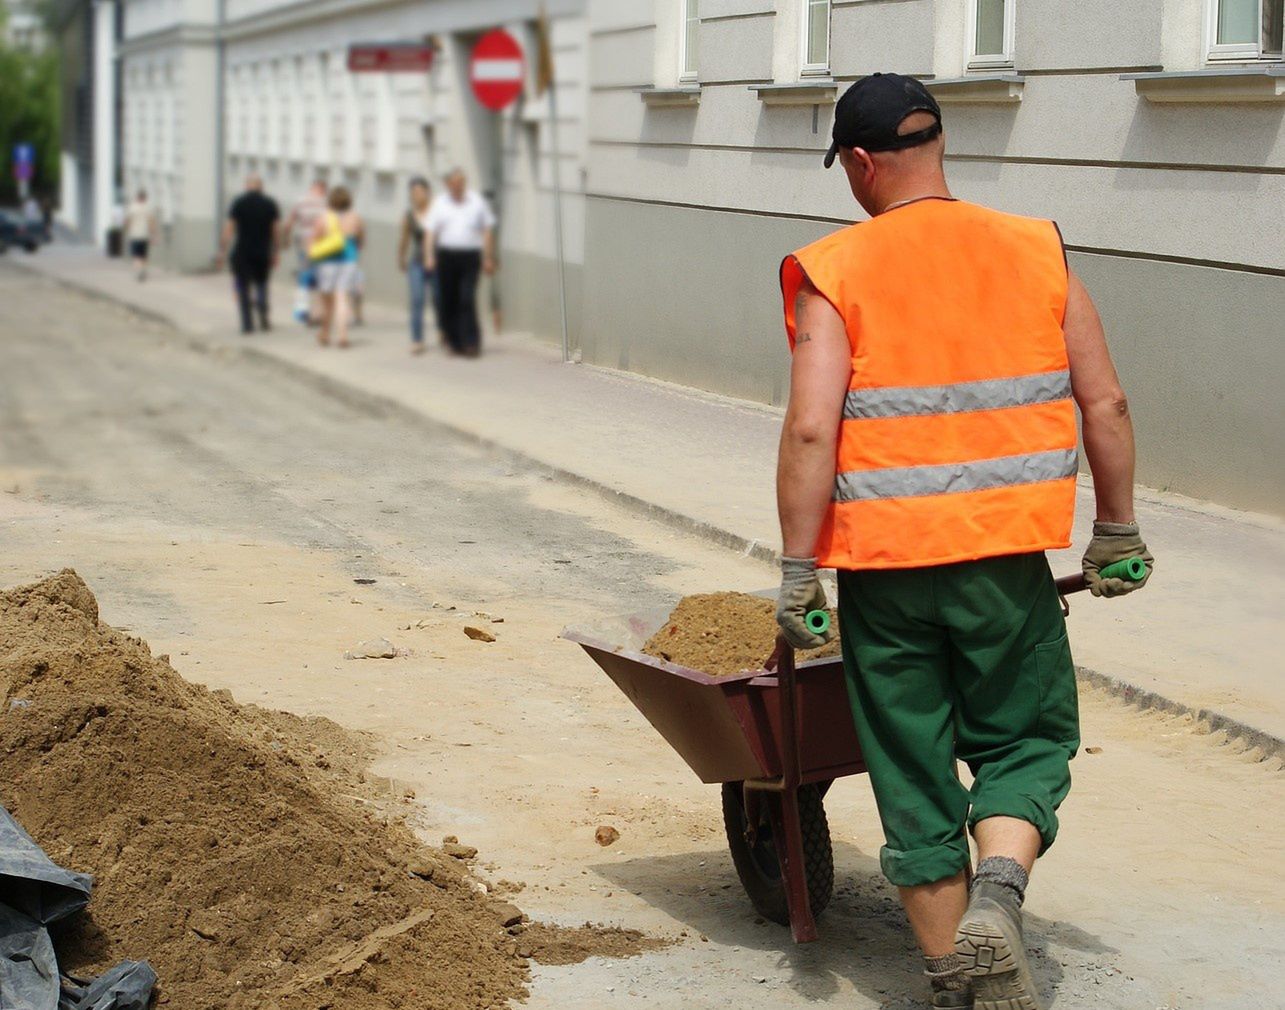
xmin=0 ymin=267 xmax=1285 ymax=1010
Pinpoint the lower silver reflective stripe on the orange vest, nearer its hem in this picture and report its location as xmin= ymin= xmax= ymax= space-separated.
xmin=834 ymin=448 xmax=1079 ymax=501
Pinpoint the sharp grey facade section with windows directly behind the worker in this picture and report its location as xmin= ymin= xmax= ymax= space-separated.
xmin=582 ymin=0 xmax=1285 ymax=513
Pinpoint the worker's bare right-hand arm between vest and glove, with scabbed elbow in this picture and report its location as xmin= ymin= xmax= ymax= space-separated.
xmin=1063 ymin=274 xmax=1135 ymax=523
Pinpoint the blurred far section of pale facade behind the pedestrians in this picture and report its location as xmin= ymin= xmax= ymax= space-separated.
xmin=111 ymin=0 xmax=587 ymax=332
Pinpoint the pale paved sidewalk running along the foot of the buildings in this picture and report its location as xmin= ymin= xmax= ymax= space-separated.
xmin=15 ymin=245 xmax=1285 ymax=753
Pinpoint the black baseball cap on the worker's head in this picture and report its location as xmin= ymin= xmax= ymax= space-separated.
xmin=825 ymin=73 xmax=942 ymax=168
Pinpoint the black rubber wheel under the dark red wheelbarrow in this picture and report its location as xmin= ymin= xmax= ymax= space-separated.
xmin=722 ymin=783 xmax=834 ymax=925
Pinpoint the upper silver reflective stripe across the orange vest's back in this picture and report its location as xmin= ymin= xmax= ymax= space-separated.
xmin=843 ymin=370 xmax=1070 ymax=420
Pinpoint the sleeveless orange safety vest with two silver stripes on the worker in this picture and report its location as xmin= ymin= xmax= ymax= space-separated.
xmin=781 ymin=199 xmax=1078 ymax=569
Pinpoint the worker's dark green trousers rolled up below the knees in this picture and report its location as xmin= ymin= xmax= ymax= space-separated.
xmin=839 ymin=554 xmax=1079 ymax=887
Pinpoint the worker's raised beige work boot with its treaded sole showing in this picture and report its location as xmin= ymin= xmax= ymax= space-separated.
xmin=955 ymin=880 xmax=1043 ymax=1010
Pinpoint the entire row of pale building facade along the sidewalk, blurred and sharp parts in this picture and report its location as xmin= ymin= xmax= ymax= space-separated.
xmin=63 ymin=0 xmax=1285 ymax=511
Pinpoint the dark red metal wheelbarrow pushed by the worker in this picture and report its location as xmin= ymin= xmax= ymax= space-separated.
xmin=563 ymin=576 xmax=1086 ymax=943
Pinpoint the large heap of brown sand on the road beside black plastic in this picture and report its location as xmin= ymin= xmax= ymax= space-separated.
xmin=0 ymin=571 xmax=657 ymax=1010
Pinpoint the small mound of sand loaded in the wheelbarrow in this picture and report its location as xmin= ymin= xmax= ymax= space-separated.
xmin=643 ymin=592 xmax=839 ymax=677
